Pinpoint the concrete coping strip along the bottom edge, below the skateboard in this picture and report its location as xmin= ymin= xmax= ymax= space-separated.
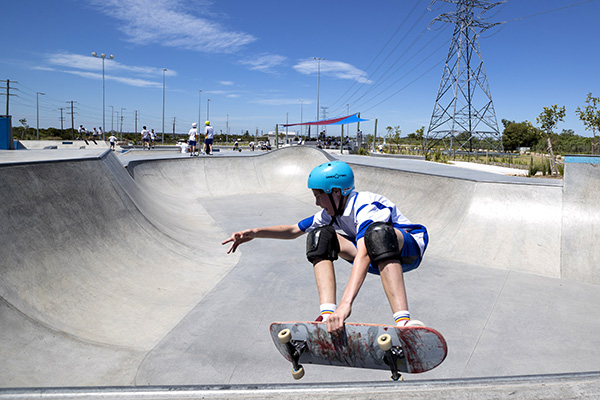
xmin=0 ymin=372 xmax=600 ymax=400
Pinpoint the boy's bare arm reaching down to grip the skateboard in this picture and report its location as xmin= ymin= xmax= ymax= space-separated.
xmin=327 ymin=238 xmax=370 ymax=333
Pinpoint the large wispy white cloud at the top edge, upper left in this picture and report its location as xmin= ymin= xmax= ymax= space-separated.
xmin=89 ymin=0 xmax=256 ymax=53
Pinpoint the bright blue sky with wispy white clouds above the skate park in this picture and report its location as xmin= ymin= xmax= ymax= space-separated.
xmin=0 ymin=0 xmax=600 ymax=136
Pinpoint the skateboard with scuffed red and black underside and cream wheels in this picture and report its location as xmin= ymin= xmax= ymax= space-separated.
xmin=270 ymin=321 xmax=448 ymax=381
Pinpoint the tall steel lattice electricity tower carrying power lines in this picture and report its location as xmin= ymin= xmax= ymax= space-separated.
xmin=425 ymin=0 xmax=503 ymax=151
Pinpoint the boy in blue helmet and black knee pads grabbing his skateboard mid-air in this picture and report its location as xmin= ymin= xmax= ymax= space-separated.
xmin=222 ymin=161 xmax=429 ymax=333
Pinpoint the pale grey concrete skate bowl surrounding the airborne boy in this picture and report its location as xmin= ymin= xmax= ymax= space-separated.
xmin=0 ymin=146 xmax=600 ymax=398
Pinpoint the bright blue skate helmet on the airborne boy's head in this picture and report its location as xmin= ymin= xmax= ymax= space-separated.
xmin=308 ymin=161 xmax=354 ymax=196
